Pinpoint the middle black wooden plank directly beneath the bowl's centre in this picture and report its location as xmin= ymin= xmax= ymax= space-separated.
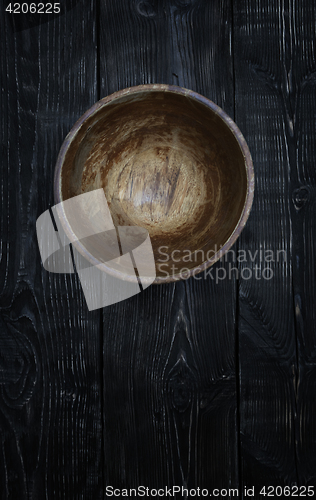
xmin=100 ymin=0 xmax=238 ymax=488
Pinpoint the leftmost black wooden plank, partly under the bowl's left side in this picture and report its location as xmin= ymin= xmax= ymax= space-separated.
xmin=0 ymin=2 xmax=102 ymax=500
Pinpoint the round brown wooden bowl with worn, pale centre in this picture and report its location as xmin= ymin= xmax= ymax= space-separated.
xmin=54 ymin=84 xmax=254 ymax=283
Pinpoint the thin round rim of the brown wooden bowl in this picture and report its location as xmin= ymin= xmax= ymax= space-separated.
xmin=54 ymin=83 xmax=255 ymax=284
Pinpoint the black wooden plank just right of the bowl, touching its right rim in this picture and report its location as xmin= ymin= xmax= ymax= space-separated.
xmin=234 ymin=0 xmax=302 ymax=490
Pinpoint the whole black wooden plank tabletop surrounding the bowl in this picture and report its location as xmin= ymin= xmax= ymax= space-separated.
xmin=0 ymin=0 xmax=316 ymax=500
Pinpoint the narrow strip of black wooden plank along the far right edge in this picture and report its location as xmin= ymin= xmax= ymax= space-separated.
xmin=286 ymin=1 xmax=316 ymax=486
